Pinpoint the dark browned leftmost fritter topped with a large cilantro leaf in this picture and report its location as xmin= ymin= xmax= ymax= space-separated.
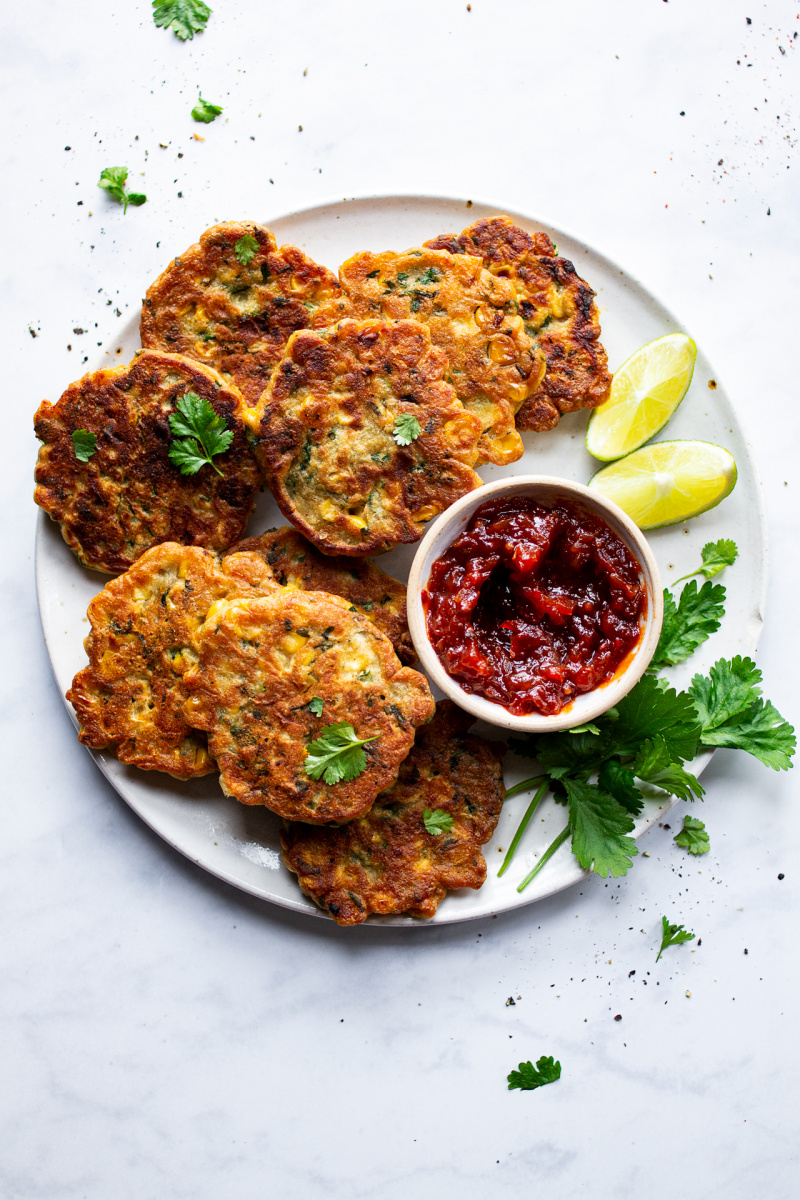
xmin=34 ymin=350 xmax=263 ymax=575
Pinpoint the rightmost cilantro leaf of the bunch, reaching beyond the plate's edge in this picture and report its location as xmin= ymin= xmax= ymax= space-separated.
xmin=688 ymin=655 xmax=796 ymax=770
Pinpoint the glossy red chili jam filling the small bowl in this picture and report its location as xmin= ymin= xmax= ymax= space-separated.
xmin=423 ymin=496 xmax=646 ymax=716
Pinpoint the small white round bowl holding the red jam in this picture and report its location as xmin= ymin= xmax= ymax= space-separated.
xmin=408 ymin=475 xmax=663 ymax=733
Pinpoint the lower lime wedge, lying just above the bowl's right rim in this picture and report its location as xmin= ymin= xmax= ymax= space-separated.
xmin=589 ymin=442 xmax=736 ymax=529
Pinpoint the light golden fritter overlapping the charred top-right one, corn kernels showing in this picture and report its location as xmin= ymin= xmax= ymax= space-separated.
xmin=313 ymin=248 xmax=545 ymax=466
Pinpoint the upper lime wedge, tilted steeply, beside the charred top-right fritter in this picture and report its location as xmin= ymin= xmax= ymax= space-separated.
xmin=587 ymin=334 xmax=697 ymax=462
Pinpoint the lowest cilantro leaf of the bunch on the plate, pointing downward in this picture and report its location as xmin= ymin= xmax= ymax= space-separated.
xmin=564 ymin=779 xmax=638 ymax=880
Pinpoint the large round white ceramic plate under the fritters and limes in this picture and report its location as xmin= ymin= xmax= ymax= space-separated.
xmin=36 ymin=197 xmax=766 ymax=928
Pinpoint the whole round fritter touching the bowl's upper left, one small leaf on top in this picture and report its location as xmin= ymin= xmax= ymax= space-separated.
xmin=253 ymin=320 xmax=484 ymax=556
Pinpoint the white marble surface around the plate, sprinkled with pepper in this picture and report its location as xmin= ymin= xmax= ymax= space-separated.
xmin=0 ymin=0 xmax=800 ymax=1200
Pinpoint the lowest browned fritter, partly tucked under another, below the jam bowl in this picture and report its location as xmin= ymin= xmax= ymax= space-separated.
xmin=281 ymin=700 xmax=504 ymax=925
